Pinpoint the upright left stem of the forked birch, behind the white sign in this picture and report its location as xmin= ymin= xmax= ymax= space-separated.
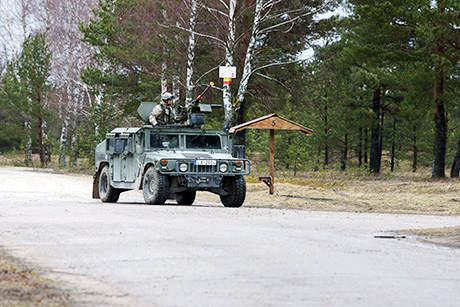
xmin=222 ymin=0 xmax=236 ymax=130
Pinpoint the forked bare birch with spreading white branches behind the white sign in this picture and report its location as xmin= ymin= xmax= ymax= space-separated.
xmin=194 ymin=0 xmax=333 ymax=129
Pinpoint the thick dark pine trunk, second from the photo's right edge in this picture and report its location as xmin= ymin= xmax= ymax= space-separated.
xmin=431 ymin=62 xmax=447 ymax=178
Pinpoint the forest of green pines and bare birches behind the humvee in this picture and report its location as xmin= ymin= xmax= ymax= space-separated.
xmin=0 ymin=0 xmax=460 ymax=178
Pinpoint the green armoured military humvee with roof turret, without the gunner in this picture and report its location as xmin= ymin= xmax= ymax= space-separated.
xmin=93 ymin=103 xmax=250 ymax=207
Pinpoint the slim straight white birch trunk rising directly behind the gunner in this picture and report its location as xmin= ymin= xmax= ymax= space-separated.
xmin=185 ymin=0 xmax=197 ymax=106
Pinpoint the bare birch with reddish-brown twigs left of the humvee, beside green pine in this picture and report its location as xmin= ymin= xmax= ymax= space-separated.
xmin=45 ymin=0 xmax=96 ymax=167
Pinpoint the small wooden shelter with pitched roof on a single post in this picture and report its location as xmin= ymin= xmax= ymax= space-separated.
xmin=229 ymin=114 xmax=313 ymax=194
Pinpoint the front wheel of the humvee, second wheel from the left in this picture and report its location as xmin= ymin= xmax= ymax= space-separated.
xmin=142 ymin=166 xmax=169 ymax=205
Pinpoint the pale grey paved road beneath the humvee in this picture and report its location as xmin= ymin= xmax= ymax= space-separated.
xmin=0 ymin=168 xmax=460 ymax=306
